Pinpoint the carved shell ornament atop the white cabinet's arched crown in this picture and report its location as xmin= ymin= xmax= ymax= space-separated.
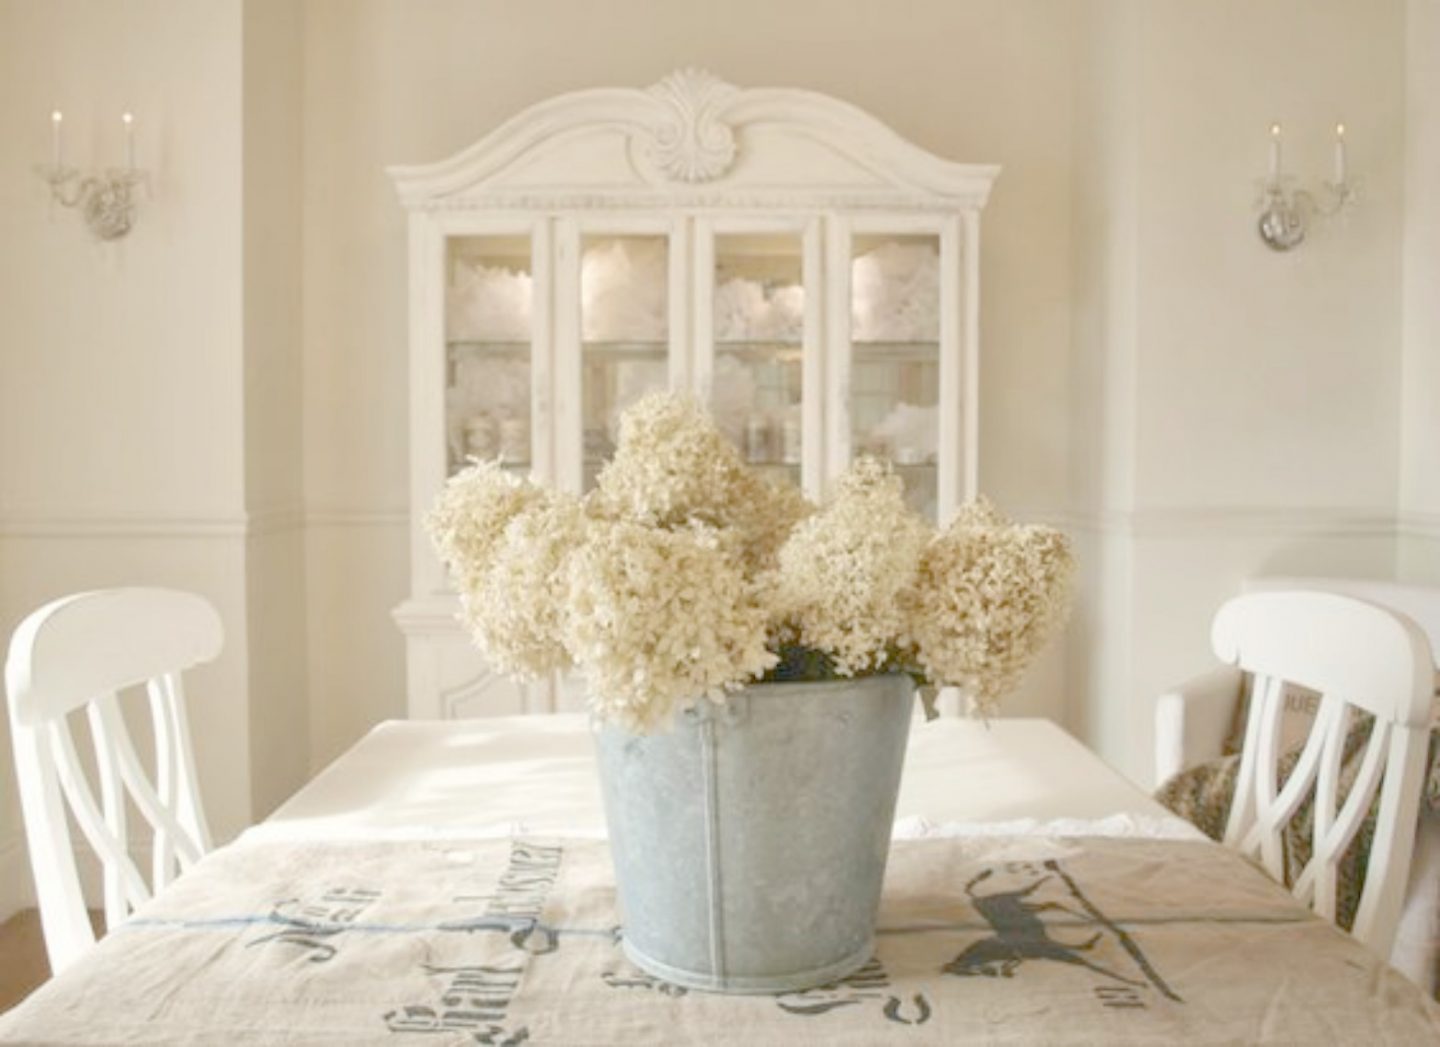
xmin=649 ymin=69 xmax=737 ymax=183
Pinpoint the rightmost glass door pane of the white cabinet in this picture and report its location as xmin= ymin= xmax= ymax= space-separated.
xmin=850 ymin=235 xmax=940 ymax=518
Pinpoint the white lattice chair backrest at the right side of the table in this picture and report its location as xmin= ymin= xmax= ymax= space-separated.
xmin=1211 ymin=592 xmax=1434 ymax=956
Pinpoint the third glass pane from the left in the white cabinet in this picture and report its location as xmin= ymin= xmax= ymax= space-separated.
xmin=710 ymin=233 xmax=805 ymax=485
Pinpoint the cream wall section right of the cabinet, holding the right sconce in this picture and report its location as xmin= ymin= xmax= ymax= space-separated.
xmin=1070 ymin=0 xmax=1405 ymax=783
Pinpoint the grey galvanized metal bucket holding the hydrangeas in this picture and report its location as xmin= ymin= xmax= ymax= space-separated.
xmin=596 ymin=675 xmax=914 ymax=992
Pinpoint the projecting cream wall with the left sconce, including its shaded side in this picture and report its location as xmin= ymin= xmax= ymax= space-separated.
xmin=0 ymin=0 xmax=308 ymax=916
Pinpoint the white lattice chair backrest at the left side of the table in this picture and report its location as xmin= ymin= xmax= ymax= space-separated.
xmin=4 ymin=588 xmax=223 ymax=972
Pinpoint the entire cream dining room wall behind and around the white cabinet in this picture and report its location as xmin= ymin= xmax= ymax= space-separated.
xmin=0 ymin=0 xmax=1422 ymax=910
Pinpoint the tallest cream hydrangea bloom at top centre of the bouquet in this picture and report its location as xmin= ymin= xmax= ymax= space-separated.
xmin=590 ymin=392 xmax=812 ymax=572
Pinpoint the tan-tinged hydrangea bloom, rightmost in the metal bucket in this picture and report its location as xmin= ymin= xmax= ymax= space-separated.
xmin=906 ymin=498 xmax=1074 ymax=716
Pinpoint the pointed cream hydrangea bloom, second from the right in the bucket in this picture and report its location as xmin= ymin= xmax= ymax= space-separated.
xmin=772 ymin=458 xmax=932 ymax=675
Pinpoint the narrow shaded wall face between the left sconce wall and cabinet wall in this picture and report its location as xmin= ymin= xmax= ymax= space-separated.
xmin=240 ymin=0 xmax=310 ymax=818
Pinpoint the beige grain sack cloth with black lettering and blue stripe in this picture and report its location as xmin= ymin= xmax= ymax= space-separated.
xmin=0 ymin=837 xmax=1440 ymax=1047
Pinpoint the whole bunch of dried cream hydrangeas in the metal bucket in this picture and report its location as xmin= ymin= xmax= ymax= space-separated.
xmin=426 ymin=395 xmax=1074 ymax=730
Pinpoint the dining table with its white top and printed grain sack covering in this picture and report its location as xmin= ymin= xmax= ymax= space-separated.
xmin=0 ymin=714 xmax=1440 ymax=1047
